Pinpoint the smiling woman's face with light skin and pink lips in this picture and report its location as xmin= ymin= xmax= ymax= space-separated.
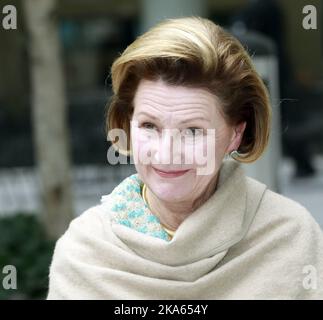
xmin=131 ymin=80 xmax=244 ymax=202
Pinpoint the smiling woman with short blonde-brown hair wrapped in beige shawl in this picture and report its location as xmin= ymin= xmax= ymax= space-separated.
xmin=48 ymin=17 xmax=323 ymax=299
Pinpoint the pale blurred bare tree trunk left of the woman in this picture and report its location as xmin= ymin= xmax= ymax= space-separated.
xmin=22 ymin=0 xmax=73 ymax=239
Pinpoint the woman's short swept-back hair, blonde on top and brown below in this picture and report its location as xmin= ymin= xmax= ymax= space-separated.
xmin=106 ymin=17 xmax=271 ymax=162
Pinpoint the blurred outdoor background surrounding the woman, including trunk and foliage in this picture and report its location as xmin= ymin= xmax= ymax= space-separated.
xmin=0 ymin=0 xmax=323 ymax=299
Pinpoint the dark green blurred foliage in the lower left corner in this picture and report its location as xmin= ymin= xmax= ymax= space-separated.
xmin=0 ymin=213 xmax=55 ymax=299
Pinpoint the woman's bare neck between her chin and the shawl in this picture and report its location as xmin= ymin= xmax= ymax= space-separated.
xmin=146 ymin=175 xmax=218 ymax=231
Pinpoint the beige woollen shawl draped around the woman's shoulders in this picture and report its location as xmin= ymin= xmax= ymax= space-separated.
xmin=48 ymin=160 xmax=323 ymax=299
